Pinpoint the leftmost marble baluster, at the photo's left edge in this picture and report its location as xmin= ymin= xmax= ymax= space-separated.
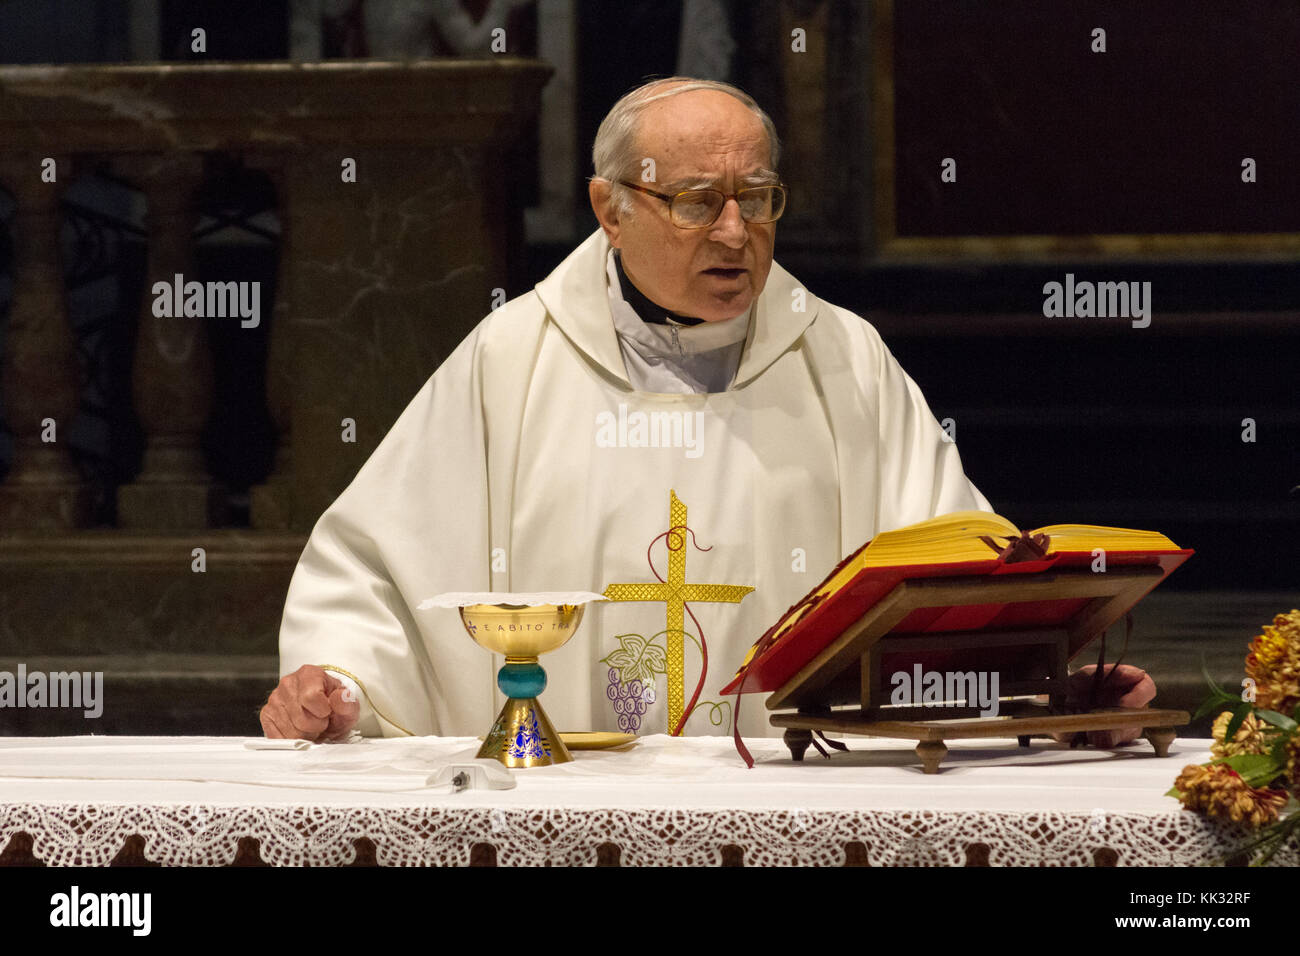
xmin=0 ymin=153 xmax=90 ymax=529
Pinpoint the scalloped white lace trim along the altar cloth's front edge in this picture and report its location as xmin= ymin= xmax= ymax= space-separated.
xmin=0 ymin=804 xmax=1300 ymax=866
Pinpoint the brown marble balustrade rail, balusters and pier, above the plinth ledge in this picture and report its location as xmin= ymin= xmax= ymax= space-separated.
xmin=0 ymin=57 xmax=550 ymax=531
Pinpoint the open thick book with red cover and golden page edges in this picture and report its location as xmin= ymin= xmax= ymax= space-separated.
xmin=722 ymin=511 xmax=1192 ymax=693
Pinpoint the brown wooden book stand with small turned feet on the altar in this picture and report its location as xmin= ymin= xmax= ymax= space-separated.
xmin=767 ymin=566 xmax=1190 ymax=774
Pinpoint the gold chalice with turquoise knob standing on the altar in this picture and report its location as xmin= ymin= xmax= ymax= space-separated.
xmin=460 ymin=594 xmax=603 ymax=767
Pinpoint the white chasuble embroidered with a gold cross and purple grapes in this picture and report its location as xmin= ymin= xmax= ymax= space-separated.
xmin=281 ymin=230 xmax=989 ymax=736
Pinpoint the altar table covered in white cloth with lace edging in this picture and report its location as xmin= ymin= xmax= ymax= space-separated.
xmin=0 ymin=735 xmax=1279 ymax=866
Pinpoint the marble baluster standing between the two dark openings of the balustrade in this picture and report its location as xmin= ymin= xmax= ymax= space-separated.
xmin=116 ymin=152 xmax=224 ymax=529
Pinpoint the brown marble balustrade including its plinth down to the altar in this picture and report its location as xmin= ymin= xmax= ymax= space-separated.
xmin=0 ymin=57 xmax=550 ymax=735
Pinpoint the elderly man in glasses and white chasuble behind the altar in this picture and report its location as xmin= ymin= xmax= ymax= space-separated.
xmin=261 ymin=77 xmax=988 ymax=739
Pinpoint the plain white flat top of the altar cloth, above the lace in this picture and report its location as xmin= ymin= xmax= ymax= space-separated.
xmin=0 ymin=734 xmax=1210 ymax=813
